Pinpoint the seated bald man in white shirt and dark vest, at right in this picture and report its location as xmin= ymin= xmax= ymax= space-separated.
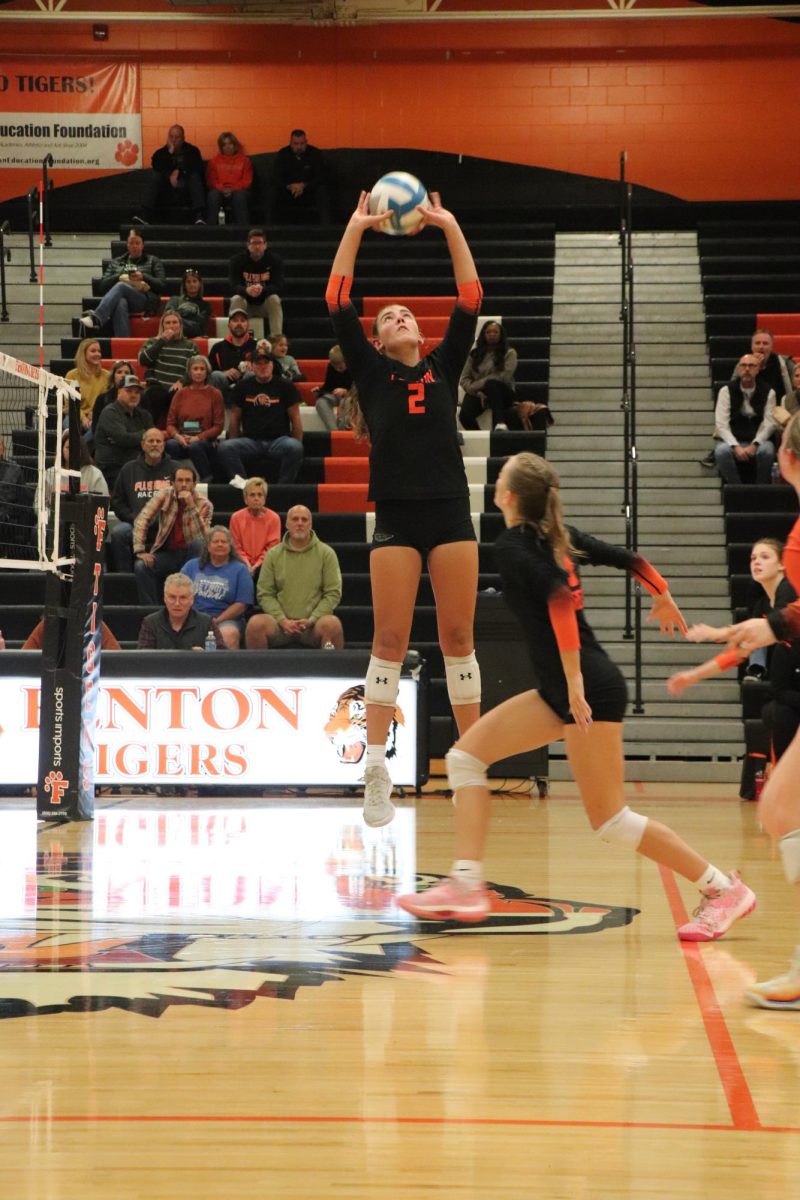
xmin=714 ymin=354 xmax=775 ymax=484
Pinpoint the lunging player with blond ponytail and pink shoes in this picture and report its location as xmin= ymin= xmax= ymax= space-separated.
xmin=398 ymin=454 xmax=756 ymax=941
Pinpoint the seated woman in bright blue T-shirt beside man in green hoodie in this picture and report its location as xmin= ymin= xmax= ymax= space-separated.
xmin=184 ymin=526 xmax=253 ymax=650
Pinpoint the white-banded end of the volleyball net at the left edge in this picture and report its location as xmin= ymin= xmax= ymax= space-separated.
xmin=0 ymin=352 xmax=80 ymax=575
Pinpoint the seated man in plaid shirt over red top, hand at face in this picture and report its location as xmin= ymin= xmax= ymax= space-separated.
xmin=133 ymin=463 xmax=213 ymax=605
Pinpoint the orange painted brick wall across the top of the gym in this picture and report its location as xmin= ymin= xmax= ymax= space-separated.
xmin=0 ymin=10 xmax=800 ymax=199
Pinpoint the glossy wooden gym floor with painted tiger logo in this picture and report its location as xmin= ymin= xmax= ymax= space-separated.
xmin=0 ymin=784 xmax=800 ymax=1200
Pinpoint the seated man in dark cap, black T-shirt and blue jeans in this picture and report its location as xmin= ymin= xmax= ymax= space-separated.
xmin=217 ymin=350 xmax=302 ymax=487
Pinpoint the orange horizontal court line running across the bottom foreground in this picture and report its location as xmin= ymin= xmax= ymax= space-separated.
xmin=0 ymin=1112 xmax=800 ymax=1133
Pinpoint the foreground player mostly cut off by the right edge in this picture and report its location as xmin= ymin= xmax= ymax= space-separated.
xmin=705 ymin=413 xmax=800 ymax=1009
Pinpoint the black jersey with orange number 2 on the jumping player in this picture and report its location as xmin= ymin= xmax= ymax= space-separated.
xmin=331 ymin=305 xmax=477 ymax=500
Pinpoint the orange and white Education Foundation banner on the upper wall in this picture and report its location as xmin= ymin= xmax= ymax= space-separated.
xmin=0 ymin=56 xmax=142 ymax=171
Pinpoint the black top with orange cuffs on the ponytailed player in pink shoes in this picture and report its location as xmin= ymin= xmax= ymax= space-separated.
xmin=494 ymin=524 xmax=667 ymax=710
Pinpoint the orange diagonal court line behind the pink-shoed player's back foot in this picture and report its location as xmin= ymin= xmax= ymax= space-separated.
xmin=658 ymin=866 xmax=763 ymax=1130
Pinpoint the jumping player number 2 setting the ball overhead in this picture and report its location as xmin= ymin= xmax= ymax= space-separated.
xmin=325 ymin=192 xmax=482 ymax=827
